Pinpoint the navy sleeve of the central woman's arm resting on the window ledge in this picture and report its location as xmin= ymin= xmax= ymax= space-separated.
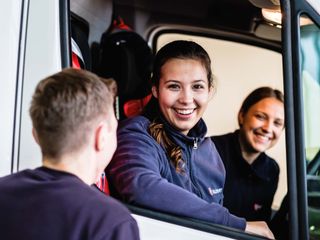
xmin=107 ymin=122 xmax=246 ymax=229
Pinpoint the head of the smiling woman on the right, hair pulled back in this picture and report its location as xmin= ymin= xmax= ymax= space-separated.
xmin=238 ymin=92 xmax=284 ymax=164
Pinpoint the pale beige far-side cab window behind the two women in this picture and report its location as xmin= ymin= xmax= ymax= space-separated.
xmin=153 ymin=30 xmax=287 ymax=211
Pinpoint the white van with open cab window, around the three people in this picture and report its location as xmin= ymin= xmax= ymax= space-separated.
xmin=0 ymin=0 xmax=320 ymax=239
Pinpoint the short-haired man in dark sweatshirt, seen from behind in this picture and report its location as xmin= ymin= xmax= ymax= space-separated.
xmin=0 ymin=68 xmax=139 ymax=240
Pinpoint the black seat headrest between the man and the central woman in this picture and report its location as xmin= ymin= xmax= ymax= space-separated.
xmin=99 ymin=30 xmax=153 ymax=101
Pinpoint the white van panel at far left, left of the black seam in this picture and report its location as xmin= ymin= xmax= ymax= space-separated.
xmin=0 ymin=0 xmax=22 ymax=176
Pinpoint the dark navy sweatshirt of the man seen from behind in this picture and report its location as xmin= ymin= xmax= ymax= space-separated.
xmin=0 ymin=170 xmax=138 ymax=239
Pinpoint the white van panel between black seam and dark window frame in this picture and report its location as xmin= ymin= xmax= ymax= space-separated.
xmin=13 ymin=0 xmax=61 ymax=171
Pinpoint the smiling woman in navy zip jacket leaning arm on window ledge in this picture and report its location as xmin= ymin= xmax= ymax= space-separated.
xmin=107 ymin=40 xmax=273 ymax=238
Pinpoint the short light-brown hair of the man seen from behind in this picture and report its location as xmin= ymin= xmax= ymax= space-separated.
xmin=30 ymin=68 xmax=113 ymax=159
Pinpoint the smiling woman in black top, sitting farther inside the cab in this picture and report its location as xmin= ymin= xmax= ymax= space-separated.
xmin=212 ymin=87 xmax=284 ymax=222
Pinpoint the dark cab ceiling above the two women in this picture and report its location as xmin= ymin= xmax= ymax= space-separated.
xmin=114 ymin=0 xmax=281 ymax=42
